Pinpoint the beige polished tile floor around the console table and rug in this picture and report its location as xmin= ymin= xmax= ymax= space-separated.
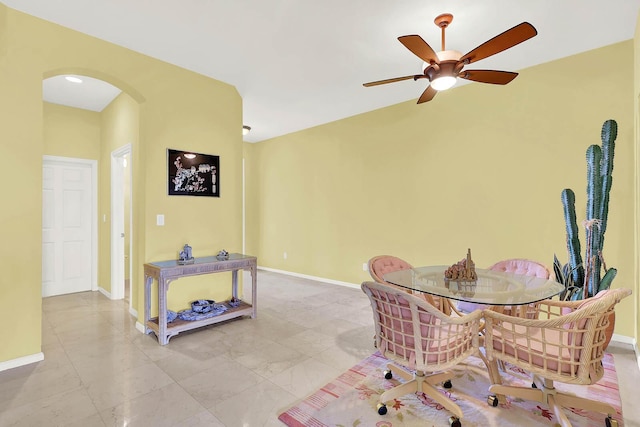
xmin=0 ymin=271 xmax=640 ymax=427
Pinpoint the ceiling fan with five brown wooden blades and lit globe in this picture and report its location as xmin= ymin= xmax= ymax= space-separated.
xmin=363 ymin=13 xmax=538 ymax=104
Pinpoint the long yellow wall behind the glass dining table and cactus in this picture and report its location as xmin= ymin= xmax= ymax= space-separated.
xmin=245 ymin=41 xmax=637 ymax=342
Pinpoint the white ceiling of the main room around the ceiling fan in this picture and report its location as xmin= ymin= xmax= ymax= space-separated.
xmin=6 ymin=0 xmax=640 ymax=142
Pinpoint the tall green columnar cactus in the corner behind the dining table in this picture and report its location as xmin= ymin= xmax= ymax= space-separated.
xmin=554 ymin=120 xmax=618 ymax=299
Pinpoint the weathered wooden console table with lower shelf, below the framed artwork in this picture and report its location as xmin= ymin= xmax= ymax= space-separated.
xmin=144 ymin=254 xmax=257 ymax=345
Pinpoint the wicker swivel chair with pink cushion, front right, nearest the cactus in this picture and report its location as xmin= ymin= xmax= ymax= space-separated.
xmin=484 ymin=289 xmax=631 ymax=427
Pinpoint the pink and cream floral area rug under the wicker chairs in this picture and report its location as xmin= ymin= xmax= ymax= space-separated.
xmin=278 ymin=352 xmax=623 ymax=427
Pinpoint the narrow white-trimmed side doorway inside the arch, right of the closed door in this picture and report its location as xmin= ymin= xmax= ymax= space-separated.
xmin=110 ymin=143 xmax=133 ymax=302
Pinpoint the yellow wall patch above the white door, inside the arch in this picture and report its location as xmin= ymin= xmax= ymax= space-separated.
xmin=43 ymin=102 xmax=100 ymax=160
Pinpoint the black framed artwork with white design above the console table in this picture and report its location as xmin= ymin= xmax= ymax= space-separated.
xmin=167 ymin=149 xmax=220 ymax=197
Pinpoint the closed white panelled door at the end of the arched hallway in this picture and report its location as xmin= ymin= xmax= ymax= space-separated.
xmin=42 ymin=160 xmax=94 ymax=297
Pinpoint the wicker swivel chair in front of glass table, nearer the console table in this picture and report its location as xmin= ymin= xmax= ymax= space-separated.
xmin=362 ymin=282 xmax=482 ymax=427
